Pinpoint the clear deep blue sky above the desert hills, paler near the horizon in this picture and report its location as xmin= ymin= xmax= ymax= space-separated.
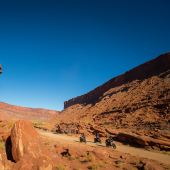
xmin=0 ymin=0 xmax=170 ymax=110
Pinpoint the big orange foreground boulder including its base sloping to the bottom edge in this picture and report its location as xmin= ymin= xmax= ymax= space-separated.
xmin=10 ymin=120 xmax=53 ymax=170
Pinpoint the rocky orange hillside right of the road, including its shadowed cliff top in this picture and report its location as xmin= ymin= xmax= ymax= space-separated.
xmin=56 ymin=53 xmax=170 ymax=150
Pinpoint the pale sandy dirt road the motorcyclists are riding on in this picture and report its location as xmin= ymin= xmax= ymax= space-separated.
xmin=38 ymin=131 xmax=170 ymax=165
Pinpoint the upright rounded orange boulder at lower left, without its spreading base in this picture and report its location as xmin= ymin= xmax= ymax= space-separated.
xmin=11 ymin=120 xmax=42 ymax=162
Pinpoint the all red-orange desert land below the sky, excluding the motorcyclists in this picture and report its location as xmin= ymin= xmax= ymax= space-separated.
xmin=0 ymin=53 xmax=170 ymax=170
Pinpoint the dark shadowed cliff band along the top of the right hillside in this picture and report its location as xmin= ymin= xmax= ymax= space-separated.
xmin=64 ymin=53 xmax=170 ymax=109
